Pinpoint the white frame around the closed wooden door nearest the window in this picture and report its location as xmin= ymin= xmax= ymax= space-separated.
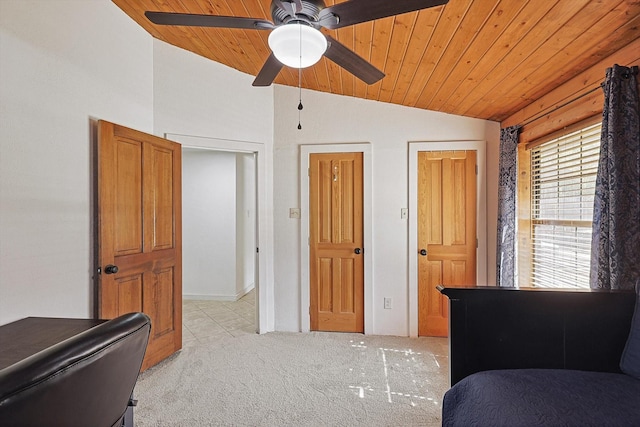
xmin=408 ymin=141 xmax=487 ymax=337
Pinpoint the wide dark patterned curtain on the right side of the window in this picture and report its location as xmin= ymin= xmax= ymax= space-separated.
xmin=590 ymin=65 xmax=640 ymax=289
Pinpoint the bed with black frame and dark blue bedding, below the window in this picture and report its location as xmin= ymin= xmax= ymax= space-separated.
xmin=441 ymin=282 xmax=640 ymax=427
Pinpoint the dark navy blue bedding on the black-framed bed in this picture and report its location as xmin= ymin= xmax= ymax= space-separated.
xmin=442 ymin=369 xmax=640 ymax=427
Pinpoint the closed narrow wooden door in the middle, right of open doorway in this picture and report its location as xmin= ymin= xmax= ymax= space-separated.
xmin=309 ymin=153 xmax=364 ymax=332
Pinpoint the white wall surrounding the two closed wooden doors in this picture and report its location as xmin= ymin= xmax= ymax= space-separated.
xmin=274 ymin=86 xmax=499 ymax=335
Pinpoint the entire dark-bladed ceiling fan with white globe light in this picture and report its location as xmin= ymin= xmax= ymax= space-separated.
xmin=145 ymin=0 xmax=449 ymax=86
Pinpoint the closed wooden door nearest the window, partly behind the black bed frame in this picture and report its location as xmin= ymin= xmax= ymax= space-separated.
xmin=417 ymin=151 xmax=477 ymax=336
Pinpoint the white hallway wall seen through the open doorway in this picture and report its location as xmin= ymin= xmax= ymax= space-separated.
xmin=182 ymin=148 xmax=256 ymax=301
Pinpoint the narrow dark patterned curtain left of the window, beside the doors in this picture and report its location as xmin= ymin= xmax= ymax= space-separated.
xmin=496 ymin=126 xmax=520 ymax=288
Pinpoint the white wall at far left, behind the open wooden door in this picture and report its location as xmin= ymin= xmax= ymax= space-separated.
xmin=0 ymin=0 xmax=153 ymax=323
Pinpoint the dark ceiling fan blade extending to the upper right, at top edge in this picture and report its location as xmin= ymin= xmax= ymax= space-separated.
xmin=318 ymin=0 xmax=449 ymax=30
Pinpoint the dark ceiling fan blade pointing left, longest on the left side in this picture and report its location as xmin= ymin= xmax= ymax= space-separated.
xmin=144 ymin=11 xmax=274 ymax=30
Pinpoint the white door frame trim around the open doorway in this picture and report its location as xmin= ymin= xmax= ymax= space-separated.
xmin=165 ymin=133 xmax=275 ymax=334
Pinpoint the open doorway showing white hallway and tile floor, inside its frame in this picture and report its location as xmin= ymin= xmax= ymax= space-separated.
xmin=182 ymin=147 xmax=257 ymax=342
